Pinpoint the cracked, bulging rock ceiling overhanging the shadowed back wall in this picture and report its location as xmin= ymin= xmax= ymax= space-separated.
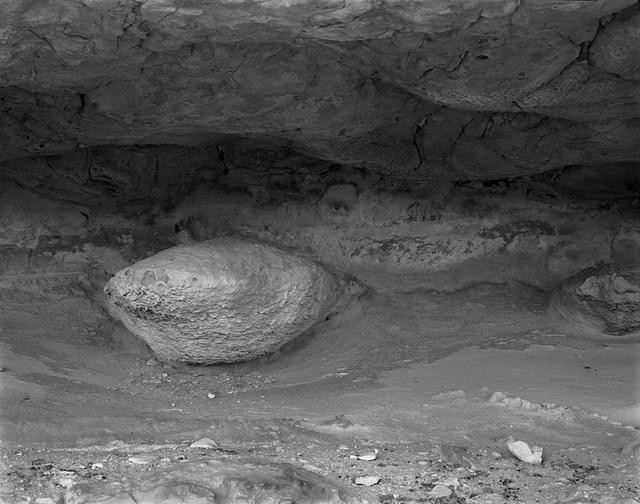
xmin=0 ymin=0 xmax=640 ymax=186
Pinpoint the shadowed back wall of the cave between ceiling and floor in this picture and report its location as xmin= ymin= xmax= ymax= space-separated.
xmin=0 ymin=173 xmax=640 ymax=298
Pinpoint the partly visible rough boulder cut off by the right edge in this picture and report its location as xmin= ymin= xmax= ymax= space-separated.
xmin=553 ymin=264 xmax=640 ymax=335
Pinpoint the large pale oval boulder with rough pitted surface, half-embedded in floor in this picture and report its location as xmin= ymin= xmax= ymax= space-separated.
xmin=104 ymin=239 xmax=340 ymax=364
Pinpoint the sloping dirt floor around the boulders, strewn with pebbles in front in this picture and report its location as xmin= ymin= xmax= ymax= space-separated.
xmin=0 ymin=276 xmax=640 ymax=504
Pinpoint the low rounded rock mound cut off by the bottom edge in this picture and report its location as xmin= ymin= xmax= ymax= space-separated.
xmin=64 ymin=460 xmax=365 ymax=504
